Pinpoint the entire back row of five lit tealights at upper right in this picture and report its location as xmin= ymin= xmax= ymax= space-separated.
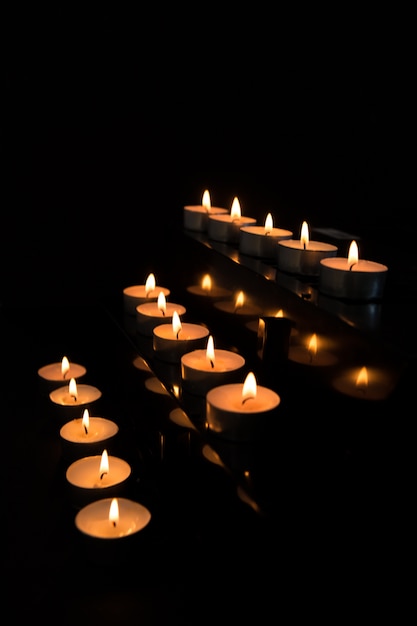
xmin=183 ymin=190 xmax=388 ymax=300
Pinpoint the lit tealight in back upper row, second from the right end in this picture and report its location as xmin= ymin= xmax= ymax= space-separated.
xmin=276 ymin=222 xmax=337 ymax=276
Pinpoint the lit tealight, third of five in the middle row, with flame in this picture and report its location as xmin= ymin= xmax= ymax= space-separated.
xmin=153 ymin=311 xmax=209 ymax=364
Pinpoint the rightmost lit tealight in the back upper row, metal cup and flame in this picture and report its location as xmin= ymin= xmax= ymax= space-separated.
xmin=319 ymin=241 xmax=388 ymax=301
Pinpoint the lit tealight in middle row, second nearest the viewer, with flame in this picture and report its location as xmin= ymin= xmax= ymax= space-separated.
xmin=181 ymin=335 xmax=245 ymax=396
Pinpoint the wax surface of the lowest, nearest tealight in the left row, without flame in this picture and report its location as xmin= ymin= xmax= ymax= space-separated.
xmin=75 ymin=498 xmax=151 ymax=539
